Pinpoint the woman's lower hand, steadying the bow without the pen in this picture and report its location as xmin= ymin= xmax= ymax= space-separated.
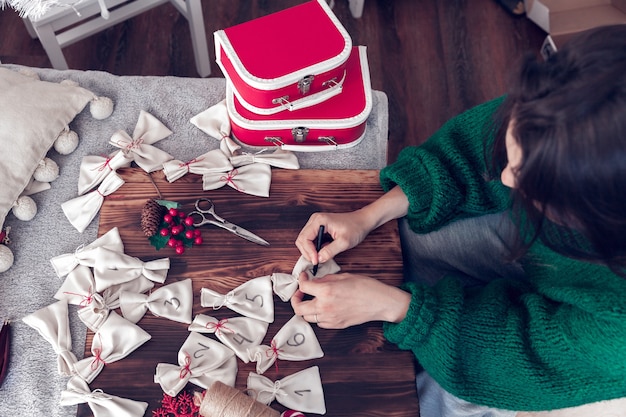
xmin=291 ymin=272 xmax=411 ymax=329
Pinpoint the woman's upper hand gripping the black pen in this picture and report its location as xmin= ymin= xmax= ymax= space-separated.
xmin=296 ymin=210 xmax=372 ymax=265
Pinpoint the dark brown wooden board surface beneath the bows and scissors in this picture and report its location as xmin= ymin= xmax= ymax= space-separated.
xmin=78 ymin=167 xmax=419 ymax=417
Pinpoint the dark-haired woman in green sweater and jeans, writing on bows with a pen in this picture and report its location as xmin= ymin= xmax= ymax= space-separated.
xmin=292 ymin=25 xmax=626 ymax=417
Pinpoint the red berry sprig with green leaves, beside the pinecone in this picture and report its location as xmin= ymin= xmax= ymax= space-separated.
xmin=150 ymin=204 xmax=203 ymax=255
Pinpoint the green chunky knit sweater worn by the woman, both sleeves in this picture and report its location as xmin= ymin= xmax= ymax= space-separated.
xmin=381 ymin=99 xmax=626 ymax=411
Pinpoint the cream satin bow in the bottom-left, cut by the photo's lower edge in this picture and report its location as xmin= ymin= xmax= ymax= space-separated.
xmin=61 ymin=377 xmax=148 ymax=417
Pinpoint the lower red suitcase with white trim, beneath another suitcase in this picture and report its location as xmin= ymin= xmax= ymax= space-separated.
xmin=226 ymin=46 xmax=372 ymax=151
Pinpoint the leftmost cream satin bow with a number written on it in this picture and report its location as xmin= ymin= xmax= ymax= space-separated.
xmin=119 ymin=278 xmax=193 ymax=324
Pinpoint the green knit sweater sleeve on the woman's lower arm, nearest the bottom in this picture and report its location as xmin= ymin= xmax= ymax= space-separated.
xmin=384 ymin=247 xmax=626 ymax=411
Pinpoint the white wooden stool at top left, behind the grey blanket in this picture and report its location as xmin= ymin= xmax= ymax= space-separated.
xmin=24 ymin=0 xmax=211 ymax=77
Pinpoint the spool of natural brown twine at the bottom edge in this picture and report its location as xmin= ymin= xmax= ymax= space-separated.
xmin=195 ymin=381 xmax=280 ymax=417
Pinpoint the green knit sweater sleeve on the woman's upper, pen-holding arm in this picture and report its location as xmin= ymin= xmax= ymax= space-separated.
xmin=380 ymin=98 xmax=509 ymax=233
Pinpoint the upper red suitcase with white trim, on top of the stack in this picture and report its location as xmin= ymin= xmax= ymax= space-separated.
xmin=214 ymin=0 xmax=352 ymax=114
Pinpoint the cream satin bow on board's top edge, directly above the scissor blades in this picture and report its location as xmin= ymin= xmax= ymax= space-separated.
xmin=202 ymin=163 xmax=272 ymax=197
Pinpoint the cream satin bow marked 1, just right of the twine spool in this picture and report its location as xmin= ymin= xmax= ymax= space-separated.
xmin=248 ymin=366 xmax=326 ymax=414
